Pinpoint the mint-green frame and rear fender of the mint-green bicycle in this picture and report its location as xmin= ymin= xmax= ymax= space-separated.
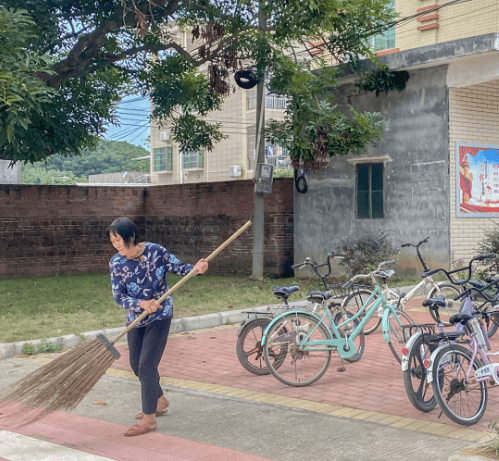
xmin=262 ymin=284 xmax=400 ymax=358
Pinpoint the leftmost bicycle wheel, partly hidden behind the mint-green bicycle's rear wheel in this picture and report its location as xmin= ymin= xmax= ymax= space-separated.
xmin=236 ymin=317 xmax=280 ymax=375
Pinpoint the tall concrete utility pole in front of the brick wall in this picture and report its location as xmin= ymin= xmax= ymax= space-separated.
xmin=251 ymin=0 xmax=265 ymax=280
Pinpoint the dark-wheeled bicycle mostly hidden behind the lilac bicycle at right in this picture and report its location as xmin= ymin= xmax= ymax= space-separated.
xmin=402 ymin=255 xmax=497 ymax=412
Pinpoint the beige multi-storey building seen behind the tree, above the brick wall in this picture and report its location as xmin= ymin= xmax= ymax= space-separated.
xmin=150 ymin=25 xmax=289 ymax=185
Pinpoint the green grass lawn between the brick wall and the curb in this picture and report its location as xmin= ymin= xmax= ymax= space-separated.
xmin=0 ymin=274 xmax=326 ymax=343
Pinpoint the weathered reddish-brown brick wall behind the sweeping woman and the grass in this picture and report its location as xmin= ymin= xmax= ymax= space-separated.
xmin=0 ymin=179 xmax=293 ymax=278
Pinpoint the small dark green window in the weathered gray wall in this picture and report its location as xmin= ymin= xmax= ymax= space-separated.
xmin=357 ymin=163 xmax=384 ymax=219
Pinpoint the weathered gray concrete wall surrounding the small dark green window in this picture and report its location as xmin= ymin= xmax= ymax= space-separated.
xmin=294 ymin=66 xmax=450 ymax=277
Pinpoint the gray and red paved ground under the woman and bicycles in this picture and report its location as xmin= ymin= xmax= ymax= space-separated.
xmin=0 ymin=301 xmax=499 ymax=461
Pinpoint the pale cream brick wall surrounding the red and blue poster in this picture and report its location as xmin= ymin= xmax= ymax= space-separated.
xmin=449 ymin=80 xmax=499 ymax=259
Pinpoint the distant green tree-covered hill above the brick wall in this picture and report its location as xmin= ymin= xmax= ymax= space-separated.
xmin=21 ymin=140 xmax=149 ymax=184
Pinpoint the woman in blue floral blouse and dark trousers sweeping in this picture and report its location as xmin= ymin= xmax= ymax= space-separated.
xmin=109 ymin=218 xmax=208 ymax=437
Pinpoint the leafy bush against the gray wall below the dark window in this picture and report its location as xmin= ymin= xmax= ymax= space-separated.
xmin=340 ymin=231 xmax=398 ymax=276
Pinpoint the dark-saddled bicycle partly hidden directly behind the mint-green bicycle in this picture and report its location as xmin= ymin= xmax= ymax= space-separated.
xmin=236 ymin=254 xmax=364 ymax=375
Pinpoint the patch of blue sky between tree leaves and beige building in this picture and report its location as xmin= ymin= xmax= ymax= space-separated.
xmin=105 ymin=96 xmax=150 ymax=149
